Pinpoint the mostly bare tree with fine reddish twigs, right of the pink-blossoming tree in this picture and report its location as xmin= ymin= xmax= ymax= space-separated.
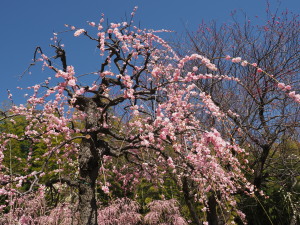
xmin=177 ymin=6 xmax=300 ymax=224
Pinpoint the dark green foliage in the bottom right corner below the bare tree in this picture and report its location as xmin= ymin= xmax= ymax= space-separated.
xmin=239 ymin=139 xmax=300 ymax=225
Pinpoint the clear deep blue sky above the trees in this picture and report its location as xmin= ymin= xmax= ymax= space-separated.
xmin=0 ymin=0 xmax=300 ymax=103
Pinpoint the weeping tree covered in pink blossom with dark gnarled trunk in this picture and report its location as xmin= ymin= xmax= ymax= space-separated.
xmin=0 ymin=7 xmax=298 ymax=224
